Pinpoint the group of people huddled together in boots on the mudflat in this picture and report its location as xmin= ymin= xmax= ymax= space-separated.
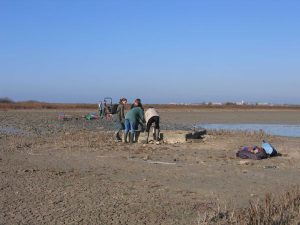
xmin=113 ymin=98 xmax=160 ymax=143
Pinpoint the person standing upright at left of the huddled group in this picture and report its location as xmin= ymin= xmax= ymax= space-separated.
xmin=113 ymin=98 xmax=127 ymax=141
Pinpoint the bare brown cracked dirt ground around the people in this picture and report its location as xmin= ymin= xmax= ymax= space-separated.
xmin=0 ymin=109 xmax=300 ymax=225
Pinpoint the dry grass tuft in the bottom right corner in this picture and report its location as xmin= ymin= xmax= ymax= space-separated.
xmin=197 ymin=186 xmax=300 ymax=225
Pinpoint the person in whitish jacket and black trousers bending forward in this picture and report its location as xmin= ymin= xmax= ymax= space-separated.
xmin=145 ymin=106 xmax=160 ymax=143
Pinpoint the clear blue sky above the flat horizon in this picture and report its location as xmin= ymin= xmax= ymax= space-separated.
xmin=0 ymin=0 xmax=300 ymax=104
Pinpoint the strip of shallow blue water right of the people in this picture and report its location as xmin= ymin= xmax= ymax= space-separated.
xmin=196 ymin=123 xmax=300 ymax=137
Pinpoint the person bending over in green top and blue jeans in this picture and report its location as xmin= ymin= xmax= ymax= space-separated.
xmin=124 ymin=107 xmax=145 ymax=143
